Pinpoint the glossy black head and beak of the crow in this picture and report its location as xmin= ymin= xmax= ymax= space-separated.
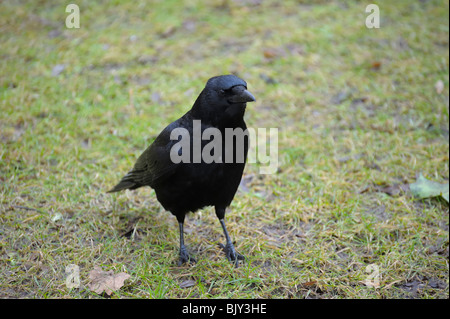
xmin=192 ymin=75 xmax=255 ymax=122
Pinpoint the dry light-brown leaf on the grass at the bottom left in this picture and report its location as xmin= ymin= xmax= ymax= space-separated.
xmin=89 ymin=266 xmax=130 ymax=296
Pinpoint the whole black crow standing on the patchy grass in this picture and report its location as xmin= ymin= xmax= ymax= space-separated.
xmin=108 ymin=75 xmax=255 ymax=265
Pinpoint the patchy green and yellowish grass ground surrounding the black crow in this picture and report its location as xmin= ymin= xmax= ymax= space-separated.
xmin=0 ymin=0 xmax=449 ymax=298
